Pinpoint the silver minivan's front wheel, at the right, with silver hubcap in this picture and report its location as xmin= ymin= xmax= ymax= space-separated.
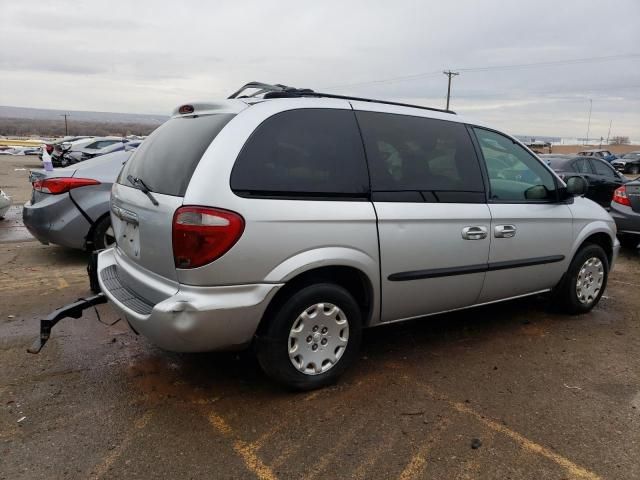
xmin=554 ymin=244 xmax=609 ymax=315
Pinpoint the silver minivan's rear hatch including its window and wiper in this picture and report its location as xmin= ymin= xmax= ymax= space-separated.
xmin=111 ymin=111 xmax=239 ymax=286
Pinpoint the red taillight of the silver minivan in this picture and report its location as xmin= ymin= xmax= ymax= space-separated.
xmin=173 ymin=207 xmax=244 ymax=268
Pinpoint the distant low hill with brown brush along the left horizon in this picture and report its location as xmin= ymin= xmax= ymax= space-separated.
xmin=0 ymin=105 xmax=169 ymax=137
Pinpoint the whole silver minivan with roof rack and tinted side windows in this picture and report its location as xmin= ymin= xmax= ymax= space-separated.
xmin=98 ymin=84 xmax=619 ymax=389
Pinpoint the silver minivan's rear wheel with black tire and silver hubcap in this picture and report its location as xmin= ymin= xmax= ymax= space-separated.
xmin=256 ymin=283 xmax=362 ymax=390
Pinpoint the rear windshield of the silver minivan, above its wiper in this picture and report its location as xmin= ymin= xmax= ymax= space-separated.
xmin=118 ymin=114 xmax=234 ymax=197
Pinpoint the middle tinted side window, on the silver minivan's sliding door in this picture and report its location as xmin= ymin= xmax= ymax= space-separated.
xmin=356 ymin=111 xmax=484 ymax=196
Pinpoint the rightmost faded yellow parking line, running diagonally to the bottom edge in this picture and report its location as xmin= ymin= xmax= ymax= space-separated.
xmin=403 ymin=375 xmax=601 ymax=480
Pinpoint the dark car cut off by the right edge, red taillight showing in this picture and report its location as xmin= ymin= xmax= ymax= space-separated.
xmin=609 ymin=180 xmax=640 ymax=248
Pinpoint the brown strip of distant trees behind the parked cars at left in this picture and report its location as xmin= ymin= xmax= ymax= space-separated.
xmin=0 ymin=118 xmax=158 ymax=137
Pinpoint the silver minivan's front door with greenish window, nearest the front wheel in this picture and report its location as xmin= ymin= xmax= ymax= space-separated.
xmin=473 ymin=128 xmax=573 ymax=303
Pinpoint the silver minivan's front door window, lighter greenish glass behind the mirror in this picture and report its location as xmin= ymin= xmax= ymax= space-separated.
xmin=473 ymin=127 xmax=556 ymax=202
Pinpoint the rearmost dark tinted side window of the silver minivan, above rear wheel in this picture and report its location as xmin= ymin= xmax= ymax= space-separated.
xmin=231 ymin=109 xmax=369 ymax=198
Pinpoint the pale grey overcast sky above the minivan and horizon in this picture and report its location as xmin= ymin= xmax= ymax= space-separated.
xmin=0 ymin=0 xmax=640 ymax=140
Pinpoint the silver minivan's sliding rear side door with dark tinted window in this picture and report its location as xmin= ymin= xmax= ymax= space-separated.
xmin=354 ymin=106 xmax=490 ymax=322
